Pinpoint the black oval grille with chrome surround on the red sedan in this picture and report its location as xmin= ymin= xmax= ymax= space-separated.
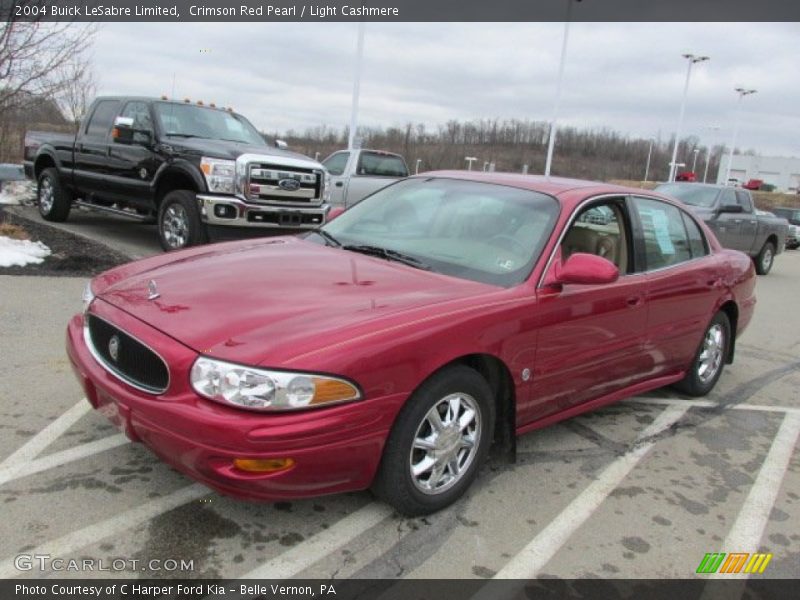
xmin=86 ymin=314 xmax=169 ymax=394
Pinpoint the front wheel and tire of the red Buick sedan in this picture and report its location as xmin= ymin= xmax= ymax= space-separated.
xmin=372 ymin=365 xmax=494 ymax=516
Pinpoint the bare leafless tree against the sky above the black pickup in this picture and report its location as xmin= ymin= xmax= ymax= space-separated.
xmin=0 ymin=0 xmax=95 ymax=113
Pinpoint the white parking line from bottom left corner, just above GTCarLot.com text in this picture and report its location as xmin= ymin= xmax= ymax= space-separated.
xmin=0 ymin=483 xmax=212 ymax=579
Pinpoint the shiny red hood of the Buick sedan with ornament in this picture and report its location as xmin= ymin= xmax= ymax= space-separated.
xmin=93 ymin=237 xmax=494 ymax=366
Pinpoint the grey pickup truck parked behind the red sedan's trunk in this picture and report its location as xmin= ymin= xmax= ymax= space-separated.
xmin=655 ymin=183 xmax=788 ymax=275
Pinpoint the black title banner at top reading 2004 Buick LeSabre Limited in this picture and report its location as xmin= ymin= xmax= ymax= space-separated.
xmin=0 ymin=0 xmax=800 ymax=26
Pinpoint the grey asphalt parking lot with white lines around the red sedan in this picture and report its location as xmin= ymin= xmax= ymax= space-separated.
xmin=0 ymin=237 xmax=800 ymax=579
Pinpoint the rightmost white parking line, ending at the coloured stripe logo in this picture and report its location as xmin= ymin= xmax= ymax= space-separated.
xmin=714 ymin=414 xmax=800 ymax=577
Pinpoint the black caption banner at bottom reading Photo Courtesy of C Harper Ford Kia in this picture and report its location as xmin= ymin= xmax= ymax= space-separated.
xmin=0 ymin=576 xmax=797 ymax=600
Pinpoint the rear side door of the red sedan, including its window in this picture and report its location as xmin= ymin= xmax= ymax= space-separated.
xmin=631 ymin=197 xmax=723 ymax=378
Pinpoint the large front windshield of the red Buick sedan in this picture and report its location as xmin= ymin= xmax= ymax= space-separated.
xmin=308 ymin=178 xmax=558 ymax=287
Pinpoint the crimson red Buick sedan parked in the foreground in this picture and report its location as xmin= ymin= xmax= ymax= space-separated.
xmin=67 ymin=172 xmax=755 ymax=514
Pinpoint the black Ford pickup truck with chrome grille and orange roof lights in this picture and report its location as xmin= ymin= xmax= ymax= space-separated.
xmin=24 ymin=96 xmax=330 ymax=250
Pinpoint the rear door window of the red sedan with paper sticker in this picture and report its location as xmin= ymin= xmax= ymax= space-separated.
xmin=634 ymin=198 xmax=692 ymax=271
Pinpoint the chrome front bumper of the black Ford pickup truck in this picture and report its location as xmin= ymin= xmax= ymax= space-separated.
xmin=197 ymin=194 xmax=330 ymax=230
